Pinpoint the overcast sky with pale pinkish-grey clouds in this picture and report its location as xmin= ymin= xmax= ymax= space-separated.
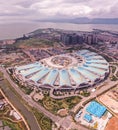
xmin=0 ymin=0 xmax=118 ymax=23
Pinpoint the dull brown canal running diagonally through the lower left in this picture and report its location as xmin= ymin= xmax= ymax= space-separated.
xmin=0 ymin=75 xmax=41 ymax=130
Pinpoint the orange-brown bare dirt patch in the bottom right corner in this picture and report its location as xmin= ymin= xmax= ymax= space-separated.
xmin=105 ymin=117 xmax=118 ymax=130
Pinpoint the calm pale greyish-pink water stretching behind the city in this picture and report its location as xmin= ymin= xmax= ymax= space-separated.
xmin=0 ymin=22 xmax=118 ymax=40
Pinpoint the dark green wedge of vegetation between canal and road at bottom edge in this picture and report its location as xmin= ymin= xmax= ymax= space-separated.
xmin=32 ymin=109 xmax=52 ymax=130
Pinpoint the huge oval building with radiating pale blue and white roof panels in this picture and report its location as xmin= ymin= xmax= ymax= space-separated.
xmin=14 ymin=50 xmax=109 ymax=91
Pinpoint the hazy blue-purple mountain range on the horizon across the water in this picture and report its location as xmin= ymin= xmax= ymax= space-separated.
xmin=35 ymin=17 xmax=118 ymax=24
